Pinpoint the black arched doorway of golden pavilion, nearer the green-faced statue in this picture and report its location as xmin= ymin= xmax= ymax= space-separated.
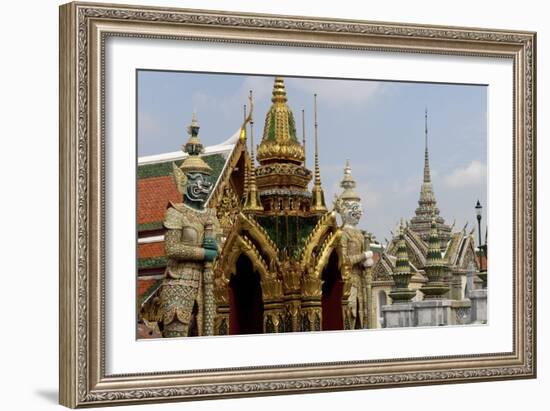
xmin=229 ymin=255 xmax=264 ymax=334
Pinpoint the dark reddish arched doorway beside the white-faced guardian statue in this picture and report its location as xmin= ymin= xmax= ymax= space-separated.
xmin=321 ymin=252 xmax=344 ymax=330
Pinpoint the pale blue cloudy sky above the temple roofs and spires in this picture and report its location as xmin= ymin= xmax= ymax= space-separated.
xmin=137 ymin=71 xmax=487 ymax=242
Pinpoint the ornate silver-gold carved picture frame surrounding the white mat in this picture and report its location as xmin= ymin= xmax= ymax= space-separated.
xmin=59 ymin=3 xmax=536 ymax=408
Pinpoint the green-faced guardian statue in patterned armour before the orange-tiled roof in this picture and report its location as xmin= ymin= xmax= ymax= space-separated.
xmin=160 ymin=115 xmax=220 ymax=337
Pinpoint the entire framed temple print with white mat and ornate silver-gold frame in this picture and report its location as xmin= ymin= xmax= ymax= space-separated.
xmin=60 ymin=3 xmax=536 ymax=407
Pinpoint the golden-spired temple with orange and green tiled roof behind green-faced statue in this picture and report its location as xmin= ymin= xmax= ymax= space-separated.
xmin=138 ymin=78 xmax=350 ymax=336
